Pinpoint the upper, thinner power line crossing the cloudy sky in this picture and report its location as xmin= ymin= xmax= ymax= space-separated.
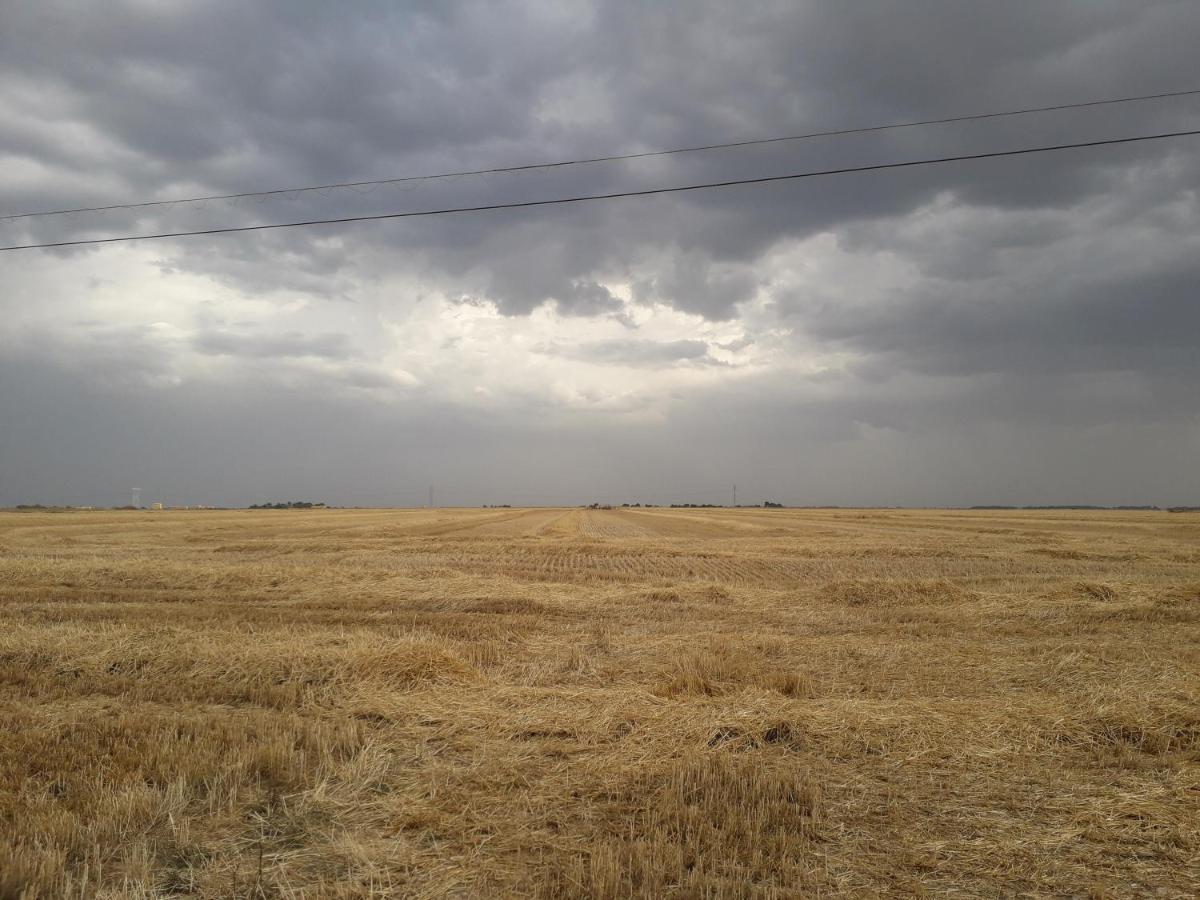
xmin=0 ymin=88 xmax=1200 ymax=222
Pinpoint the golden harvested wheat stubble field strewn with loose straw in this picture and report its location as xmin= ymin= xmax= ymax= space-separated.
xmin=0 ymin=509 xmax=1200 ymax=898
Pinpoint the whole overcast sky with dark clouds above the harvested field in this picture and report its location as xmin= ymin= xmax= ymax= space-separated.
xmin=0 ymin=0 xmax=1200 ymax=505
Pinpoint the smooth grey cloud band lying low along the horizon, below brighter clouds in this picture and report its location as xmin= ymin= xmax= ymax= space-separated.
xmin=0 ymin=348 xmax=1200 ymax=505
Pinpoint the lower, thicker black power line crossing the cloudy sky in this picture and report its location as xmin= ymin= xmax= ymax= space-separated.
xmin=0 ymin=130 xmax=1200 ymax=252
